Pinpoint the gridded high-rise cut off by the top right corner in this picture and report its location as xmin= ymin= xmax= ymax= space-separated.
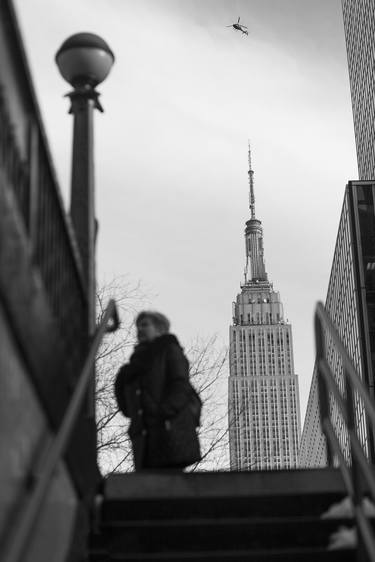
xmin=342 ymin=0 xmax=375 ymax=180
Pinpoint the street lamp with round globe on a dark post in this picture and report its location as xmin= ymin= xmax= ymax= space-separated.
xmin=55 ymin=33 xmax=115 ymax=334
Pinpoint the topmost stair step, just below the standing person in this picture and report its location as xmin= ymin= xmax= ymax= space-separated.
xmin=103 ymin=469 xmax=346 ymax=521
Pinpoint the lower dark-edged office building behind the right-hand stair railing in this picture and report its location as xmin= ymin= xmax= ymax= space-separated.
xmin=300 ymin=182 xmax=375 ymax=468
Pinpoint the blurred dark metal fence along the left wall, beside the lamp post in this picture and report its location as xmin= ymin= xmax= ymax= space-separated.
xmin=0 ymin=89 xmax=88 ymax=370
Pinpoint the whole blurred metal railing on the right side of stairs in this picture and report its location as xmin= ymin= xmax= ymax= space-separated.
xmin=314 ymin=302 xmax=375 ymax=561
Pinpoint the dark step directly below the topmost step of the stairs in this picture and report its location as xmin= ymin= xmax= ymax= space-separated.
xmin=92 ymin=517 xmax=354 ymax=554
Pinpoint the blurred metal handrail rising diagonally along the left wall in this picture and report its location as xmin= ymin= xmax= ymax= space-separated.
xmin=2 ymin=300 xmax=120 ymax=562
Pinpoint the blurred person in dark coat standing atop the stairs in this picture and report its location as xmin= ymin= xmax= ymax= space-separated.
xmin=115 ymin=311 xmax=202 ymax=471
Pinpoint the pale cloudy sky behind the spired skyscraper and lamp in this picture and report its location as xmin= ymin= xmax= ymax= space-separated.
xmin=15 ymin=0 xmax=358 ymax=420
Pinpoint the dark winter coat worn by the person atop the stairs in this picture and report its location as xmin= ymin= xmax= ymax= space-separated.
xmin=115 ymin=334 xmax=199 ymax=470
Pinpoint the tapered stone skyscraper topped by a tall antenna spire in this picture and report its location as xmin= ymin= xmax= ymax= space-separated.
xmin=229 ymin=146 xmax=300 ymax=470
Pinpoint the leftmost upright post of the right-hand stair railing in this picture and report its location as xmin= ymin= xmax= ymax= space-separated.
xmin=314 ymin=303 xmax=333 ymax=466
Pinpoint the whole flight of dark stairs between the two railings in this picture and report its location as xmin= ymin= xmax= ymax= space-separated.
xmin=90 ymin=469 xmax=356 ymax=562
